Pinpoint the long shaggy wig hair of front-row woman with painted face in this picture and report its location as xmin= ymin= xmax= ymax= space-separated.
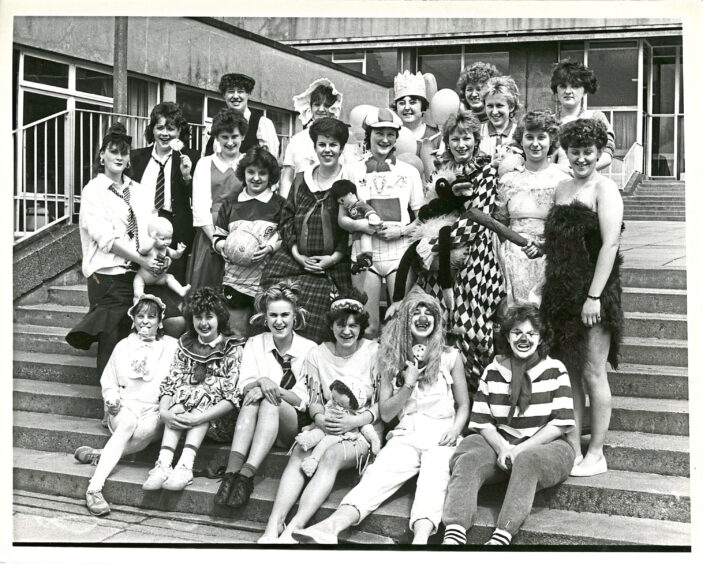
xmin=375 ymin=287 xmax=444 ymax=385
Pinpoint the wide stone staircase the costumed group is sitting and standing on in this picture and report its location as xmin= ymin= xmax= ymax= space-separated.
xmin=13 ymin=269 xmax=691 ymax=546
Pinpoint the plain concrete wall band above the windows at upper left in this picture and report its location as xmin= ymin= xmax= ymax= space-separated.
xmin=14 ymin=16 xmax=388 ymax=118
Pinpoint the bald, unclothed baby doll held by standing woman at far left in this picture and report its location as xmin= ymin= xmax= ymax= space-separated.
xmin=134 ymin=217 xmax=190 ymax=303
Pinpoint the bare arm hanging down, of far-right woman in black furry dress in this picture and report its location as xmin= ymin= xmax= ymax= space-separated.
xmin=581 ymin=178 xmax=623 ymax=327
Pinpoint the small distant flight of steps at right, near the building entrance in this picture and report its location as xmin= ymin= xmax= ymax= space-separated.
xmin=623 ymin=180 xmax=686 ymax=221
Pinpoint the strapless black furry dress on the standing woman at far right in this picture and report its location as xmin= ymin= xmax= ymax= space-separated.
xmin=542 ymin=202 xmax=624 ymax=369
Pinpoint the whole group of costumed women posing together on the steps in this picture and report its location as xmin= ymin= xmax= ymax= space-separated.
xmin=67 ymin=61 xmax=623 ymax=544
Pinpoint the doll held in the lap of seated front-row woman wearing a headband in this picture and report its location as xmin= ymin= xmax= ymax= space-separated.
xmin=295 ymin=379 xmax=381 ymax=477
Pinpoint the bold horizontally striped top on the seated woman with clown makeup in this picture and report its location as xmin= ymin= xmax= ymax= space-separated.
xmin=469 ymin=356 xmax=574 ymax=444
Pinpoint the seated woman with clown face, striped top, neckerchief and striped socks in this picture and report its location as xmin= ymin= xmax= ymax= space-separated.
xmin=442 ymin=304 xmax=575 ymax=545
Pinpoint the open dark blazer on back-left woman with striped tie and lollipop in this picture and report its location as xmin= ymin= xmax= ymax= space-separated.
xmin=129 ymin=145 xmax=200 ymax=249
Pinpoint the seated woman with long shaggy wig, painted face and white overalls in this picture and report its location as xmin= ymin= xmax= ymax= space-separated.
xmin=293 ymin=289 xmax=469 ymax=544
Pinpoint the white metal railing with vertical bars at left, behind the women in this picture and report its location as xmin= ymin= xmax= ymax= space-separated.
xmin=12 ymin=109 xmax=205 ymax=244
